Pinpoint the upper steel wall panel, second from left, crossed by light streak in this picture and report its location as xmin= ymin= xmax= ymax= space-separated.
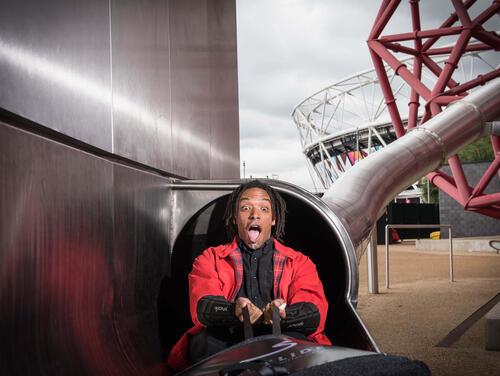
xmin=111 ymin=0 xmax=172 ymax=171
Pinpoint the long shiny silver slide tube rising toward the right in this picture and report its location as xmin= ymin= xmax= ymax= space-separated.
xmin=323 ymin=79 xmax=500 ymax=258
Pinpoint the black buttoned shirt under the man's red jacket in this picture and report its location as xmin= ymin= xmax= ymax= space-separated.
xmin=236 ymin=238 xmax=274 ymax=308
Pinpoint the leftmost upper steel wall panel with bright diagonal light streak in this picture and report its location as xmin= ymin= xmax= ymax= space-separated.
xmin=0 ymin=0 xmax=111 ymax=151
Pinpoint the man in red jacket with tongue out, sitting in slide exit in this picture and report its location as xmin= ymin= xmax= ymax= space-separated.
xmin=168 ymin=180 xmax=331 ymax=371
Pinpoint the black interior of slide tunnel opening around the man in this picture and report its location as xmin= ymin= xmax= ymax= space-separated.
xmin=159 ymin=192 xmax=374 ymax=354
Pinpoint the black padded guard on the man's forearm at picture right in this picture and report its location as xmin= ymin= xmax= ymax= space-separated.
xmin=281 ymin=302 xmax=320 ymax=335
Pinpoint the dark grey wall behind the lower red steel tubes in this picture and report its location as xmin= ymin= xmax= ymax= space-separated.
xmin=439 ymin=163 xmax=500 ymax=237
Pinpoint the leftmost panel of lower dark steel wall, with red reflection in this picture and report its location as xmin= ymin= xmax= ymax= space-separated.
xmin=0 ymin=124 xmax=113 ymax=375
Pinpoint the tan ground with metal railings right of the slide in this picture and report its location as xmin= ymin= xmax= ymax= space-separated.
xmin=358 ymin=242 xmax=500 ymax=376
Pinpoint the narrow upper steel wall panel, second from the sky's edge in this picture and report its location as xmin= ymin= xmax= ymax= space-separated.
xmin=170 ymin=0 xmax=210 ymax=179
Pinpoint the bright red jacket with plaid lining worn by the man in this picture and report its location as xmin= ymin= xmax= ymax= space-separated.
xmin=168 ymin=239 xmax=331 ymax=371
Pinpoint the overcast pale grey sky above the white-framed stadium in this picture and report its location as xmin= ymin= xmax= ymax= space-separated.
xmin=237 ymin=0 xmax=498 ymax=189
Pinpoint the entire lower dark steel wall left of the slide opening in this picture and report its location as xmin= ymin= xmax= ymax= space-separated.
xmin=0 ymin=122 xmax=171 ymax=375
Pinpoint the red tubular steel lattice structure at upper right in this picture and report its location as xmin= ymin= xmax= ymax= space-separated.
xmin=368 ymin=0 xmax=500 ymax=219
